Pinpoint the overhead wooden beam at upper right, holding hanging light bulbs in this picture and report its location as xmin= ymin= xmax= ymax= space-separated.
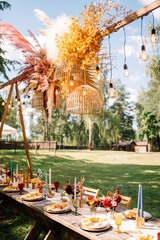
xmin=106 ymin=0 xmax=160 ymax=34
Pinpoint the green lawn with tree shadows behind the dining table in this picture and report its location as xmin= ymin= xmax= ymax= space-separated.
xmin=0 ymin=150 xmax=160 ymax=240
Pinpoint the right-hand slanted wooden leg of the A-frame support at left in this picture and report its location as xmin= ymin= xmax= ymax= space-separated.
xmin=15 ymin=83 xmax=33 ymax=178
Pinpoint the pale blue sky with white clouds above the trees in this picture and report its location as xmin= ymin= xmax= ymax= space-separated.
xmin=0 ymin=0 xmax=160 ymax=135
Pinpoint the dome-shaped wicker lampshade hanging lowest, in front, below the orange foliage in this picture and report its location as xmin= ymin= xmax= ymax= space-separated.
xmin=66 ymin=85 xmax=102 ymax=114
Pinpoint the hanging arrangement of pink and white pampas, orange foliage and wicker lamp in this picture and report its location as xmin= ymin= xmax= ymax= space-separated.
xmin=0 ymin=0 xmax=130 ymax=119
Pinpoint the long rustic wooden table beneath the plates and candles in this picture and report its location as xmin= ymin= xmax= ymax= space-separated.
xmin=0 ymin=187 xmax=160 ymax=240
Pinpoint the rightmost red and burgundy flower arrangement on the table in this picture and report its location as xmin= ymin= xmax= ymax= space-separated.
xmin=103 ymin=188 xmax=121 ymax=211
